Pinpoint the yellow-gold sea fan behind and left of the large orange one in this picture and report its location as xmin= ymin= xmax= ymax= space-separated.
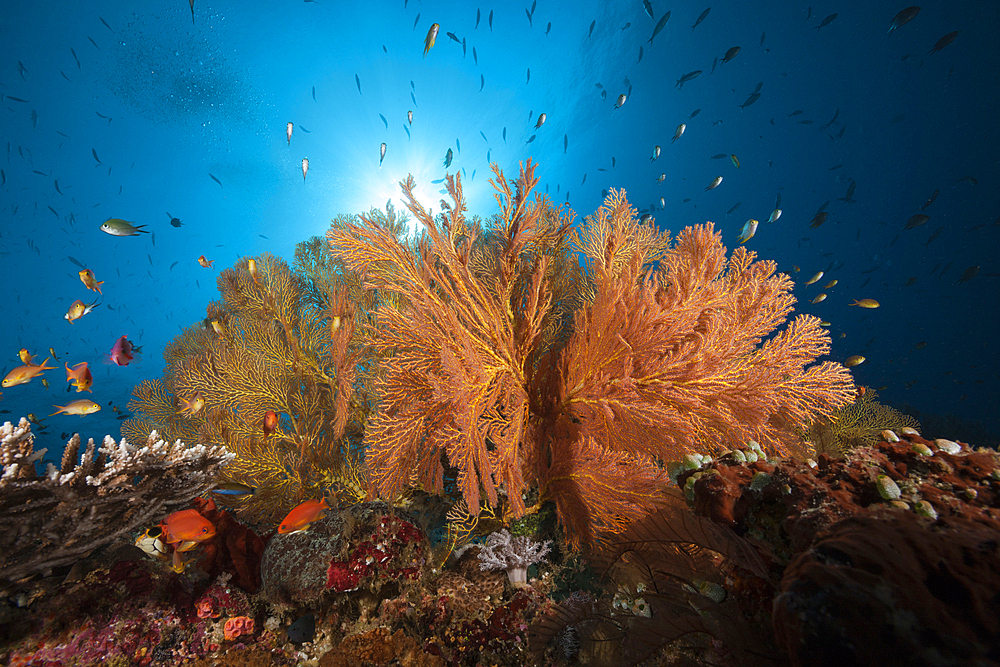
xmin=123 ymin=252 xmax=372 ymax=521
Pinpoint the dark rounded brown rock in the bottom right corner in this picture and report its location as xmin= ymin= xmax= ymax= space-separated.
xmin=773 ymin=510 xmax=1000 ymax=667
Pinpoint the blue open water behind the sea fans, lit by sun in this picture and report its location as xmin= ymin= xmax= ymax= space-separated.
xmin=0 ymin=0 xmax=1000 ymax=451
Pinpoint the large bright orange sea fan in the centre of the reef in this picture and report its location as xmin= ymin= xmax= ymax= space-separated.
xmin=327 ymin=160 xmax=855 ymax=544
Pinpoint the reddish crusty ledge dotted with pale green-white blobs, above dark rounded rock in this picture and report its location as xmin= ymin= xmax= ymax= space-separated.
xmin=678 ymin=433 xmax=1000 ymax=563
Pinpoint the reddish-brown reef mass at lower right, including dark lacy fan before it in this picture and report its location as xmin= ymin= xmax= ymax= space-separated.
xmin=528 ymin=428 xmax=1000 ymax=665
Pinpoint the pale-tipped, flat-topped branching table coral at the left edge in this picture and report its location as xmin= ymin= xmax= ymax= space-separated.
xmin=0 ymin=418 xmax=234 ymax=589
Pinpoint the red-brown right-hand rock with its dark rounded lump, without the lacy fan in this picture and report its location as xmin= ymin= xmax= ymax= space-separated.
xmin=678 ymin=432 xmax=1000 ymax=667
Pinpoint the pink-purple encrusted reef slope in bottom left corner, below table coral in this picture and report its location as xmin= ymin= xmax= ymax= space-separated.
xmin=0 ymin=545 xmax=294 ymax=667
